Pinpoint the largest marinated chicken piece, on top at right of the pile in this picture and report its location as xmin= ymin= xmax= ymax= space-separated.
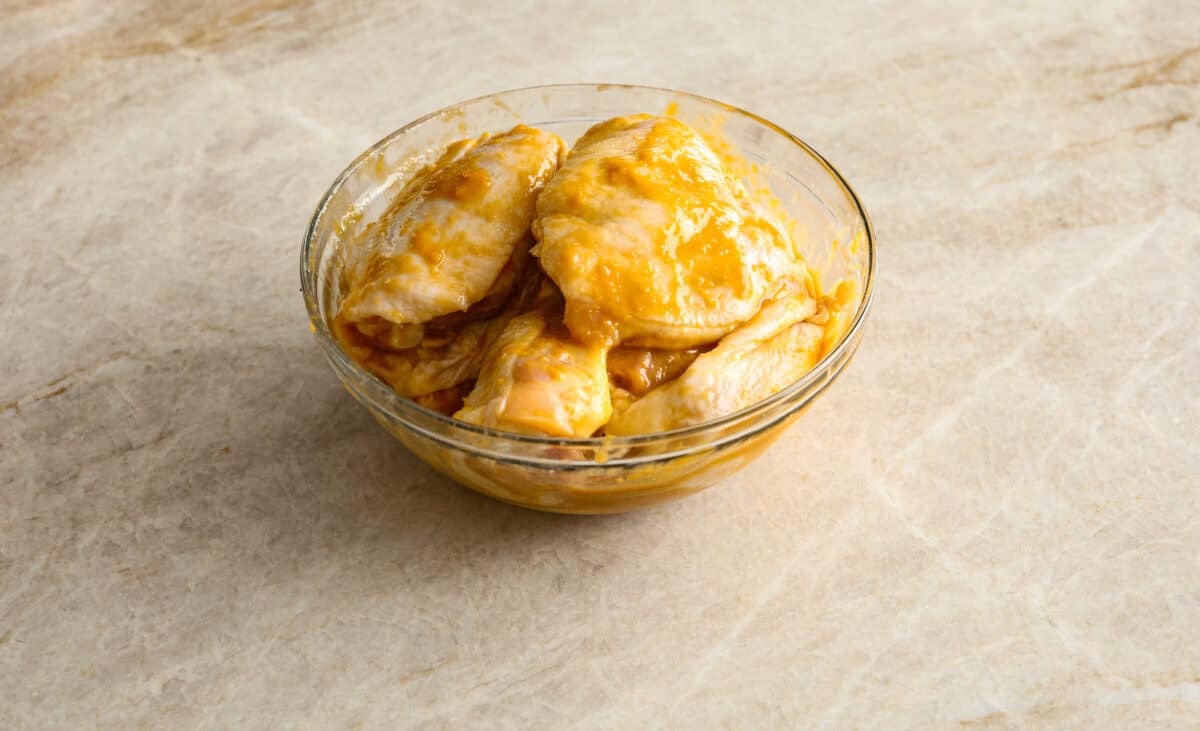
xmin=533 ymin=115 xmax=806 ymax=349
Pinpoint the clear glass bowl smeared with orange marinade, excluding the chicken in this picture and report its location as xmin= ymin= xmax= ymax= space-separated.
xmin=300 ymin=84 xmax=875 ymax=513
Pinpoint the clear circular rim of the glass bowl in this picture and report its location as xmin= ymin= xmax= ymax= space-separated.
xmin=300 ymin=83 xmax=876 ymax=451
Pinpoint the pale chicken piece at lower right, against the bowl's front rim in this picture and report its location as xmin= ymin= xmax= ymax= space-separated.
xmin=605 ymin=294 xmax=824 ymax=435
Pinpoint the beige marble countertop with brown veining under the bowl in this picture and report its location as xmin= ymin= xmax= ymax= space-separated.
xmin=0 ymin=0 xmax=1200 ymax=729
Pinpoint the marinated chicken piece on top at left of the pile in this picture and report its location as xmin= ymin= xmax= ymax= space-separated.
xmin=337 ymin=125 xmax=565 ymax=349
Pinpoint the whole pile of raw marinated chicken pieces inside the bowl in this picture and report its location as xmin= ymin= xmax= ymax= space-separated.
xmin=334 ymin=115 xmax=850 ymax=438
